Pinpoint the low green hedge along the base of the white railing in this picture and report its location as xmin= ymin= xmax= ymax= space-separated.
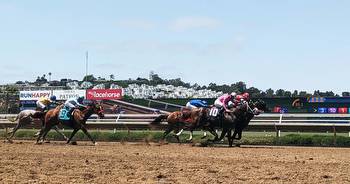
xmin=0 ymin=130 xmax=350 ymax=147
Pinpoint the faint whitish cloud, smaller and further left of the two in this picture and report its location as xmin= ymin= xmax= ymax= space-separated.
xmin=118 ymin=19 xmax=156 ymax=30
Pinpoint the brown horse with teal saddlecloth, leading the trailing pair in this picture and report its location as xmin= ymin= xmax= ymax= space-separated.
xmin=36 ymin=102 xmax=104 ymax=145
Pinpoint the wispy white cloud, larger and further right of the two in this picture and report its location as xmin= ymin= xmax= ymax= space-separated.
xmin=170 ymin=17 xmax=221 ymax=32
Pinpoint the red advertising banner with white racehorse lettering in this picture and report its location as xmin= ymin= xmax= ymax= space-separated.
xmin=86 ymin=89 xmax=122 ymax=100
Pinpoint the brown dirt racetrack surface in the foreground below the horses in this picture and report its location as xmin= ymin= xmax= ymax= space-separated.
xmin=0 ymin=141 xmax=350 ymax=184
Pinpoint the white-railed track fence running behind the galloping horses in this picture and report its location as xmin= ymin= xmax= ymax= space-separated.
xmin=0 ymin=114 xmax=350 ymax=136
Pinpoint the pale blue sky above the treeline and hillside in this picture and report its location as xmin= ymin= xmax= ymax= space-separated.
xmin=0 ymin=0 xmax=350 ymax=94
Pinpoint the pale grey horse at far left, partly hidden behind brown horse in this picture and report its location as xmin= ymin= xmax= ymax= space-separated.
xmin=6 ymin=110 xmax=68 ymax=143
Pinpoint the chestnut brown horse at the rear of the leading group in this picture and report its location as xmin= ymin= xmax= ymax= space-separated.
xmin=151 ymin=108 xmax=218 ymax=143
